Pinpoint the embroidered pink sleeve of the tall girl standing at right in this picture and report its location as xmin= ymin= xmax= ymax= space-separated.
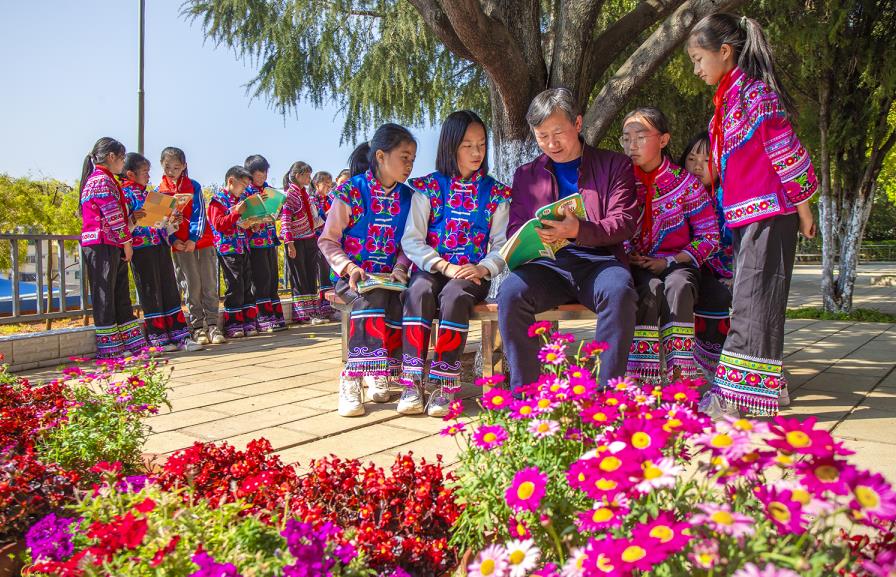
xmin=761 ymin=104 xmax=818 ymax=204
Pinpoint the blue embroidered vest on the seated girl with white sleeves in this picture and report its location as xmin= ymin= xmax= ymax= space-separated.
xmin=411 ymin=172 xmax=510 ymax=265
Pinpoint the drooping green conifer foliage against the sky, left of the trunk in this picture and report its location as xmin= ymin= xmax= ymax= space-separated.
xmin=183 ymin=0 xmax=490 ymax=140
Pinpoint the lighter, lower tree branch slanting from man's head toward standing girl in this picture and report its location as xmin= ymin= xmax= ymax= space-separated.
xmin=583 ymin=0 xmax=745 ymax=144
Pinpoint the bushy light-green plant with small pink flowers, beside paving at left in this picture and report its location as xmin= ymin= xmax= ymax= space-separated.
xmin=38 ymin=359 xmax=170 ymax=473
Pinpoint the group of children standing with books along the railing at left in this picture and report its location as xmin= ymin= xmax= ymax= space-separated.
xmin=80 ymin=145 xmax=342 ymax=358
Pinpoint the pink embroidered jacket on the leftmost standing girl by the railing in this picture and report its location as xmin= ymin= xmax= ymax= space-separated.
xmin=80 ymin=166 xmax=131 ymax=246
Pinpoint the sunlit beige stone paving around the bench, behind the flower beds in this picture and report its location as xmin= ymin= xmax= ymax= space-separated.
xmin=15 ymin=265 xmax=896 ymax=482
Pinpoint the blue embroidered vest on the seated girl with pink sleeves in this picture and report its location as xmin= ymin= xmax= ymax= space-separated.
xmin=334 ymin=170 xmax=413 ymax=273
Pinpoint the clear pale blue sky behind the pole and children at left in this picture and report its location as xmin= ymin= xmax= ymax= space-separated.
xmin=0 ymin=0 xmax=438 ymax=185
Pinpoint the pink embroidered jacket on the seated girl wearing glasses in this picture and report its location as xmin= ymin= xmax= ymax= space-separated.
xmin=628 ymin=158 xmax=720 ymax=267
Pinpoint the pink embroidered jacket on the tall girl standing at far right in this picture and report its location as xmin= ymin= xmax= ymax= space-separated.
xmin=710 ymin=68 xmax=818 ymax=228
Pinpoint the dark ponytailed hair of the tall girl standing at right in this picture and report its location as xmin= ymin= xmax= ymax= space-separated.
xmin=690 ymin=12 xmax=796 ymax=117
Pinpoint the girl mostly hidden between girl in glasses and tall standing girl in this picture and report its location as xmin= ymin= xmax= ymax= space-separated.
xmin=679 ymin=132 xmax=734 ymax=382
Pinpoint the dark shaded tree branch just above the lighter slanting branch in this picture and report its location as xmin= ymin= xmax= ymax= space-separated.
xmin=578 ymin=0 xmax=684 ymax=105
